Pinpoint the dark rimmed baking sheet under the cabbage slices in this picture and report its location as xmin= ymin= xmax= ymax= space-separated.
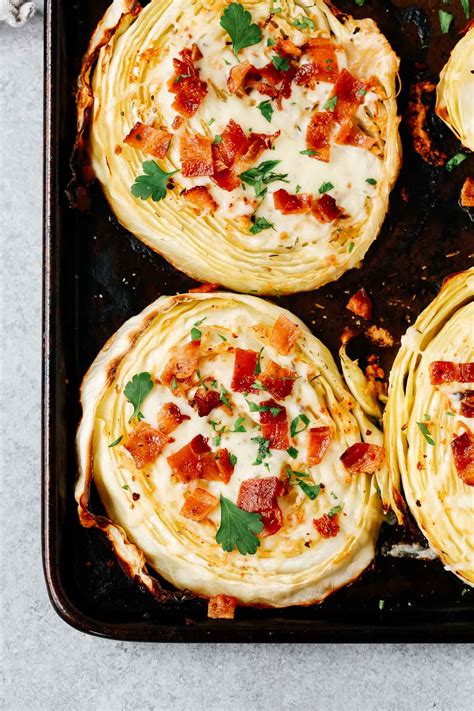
xmin=43 ymin=0 xmax=474 ymax=642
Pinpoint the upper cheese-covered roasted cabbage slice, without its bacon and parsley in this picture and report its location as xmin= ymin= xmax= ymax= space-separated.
xmin=81 ymin=0 xmax=400 ymax=293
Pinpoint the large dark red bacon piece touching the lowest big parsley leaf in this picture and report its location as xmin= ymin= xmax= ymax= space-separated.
xmin=237 ymin=476 xmax=285 ymax=536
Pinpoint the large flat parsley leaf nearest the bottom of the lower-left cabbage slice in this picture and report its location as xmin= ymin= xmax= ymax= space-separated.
xmin=216 ymin=494 xmax=263 ymax=555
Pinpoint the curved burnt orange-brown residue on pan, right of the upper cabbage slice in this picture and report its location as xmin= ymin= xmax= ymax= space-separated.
xmin=406 ymin=81 xmax=448 ymax=165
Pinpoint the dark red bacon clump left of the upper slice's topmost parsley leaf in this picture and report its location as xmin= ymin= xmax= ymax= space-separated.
xmin=168 ymin=44 xmax=207 ymax=118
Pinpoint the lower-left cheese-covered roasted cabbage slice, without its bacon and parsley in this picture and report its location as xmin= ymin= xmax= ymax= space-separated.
xmin=77 ymin=293 xmax=387 ymax=606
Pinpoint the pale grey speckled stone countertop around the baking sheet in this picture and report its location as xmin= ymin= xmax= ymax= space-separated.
xmin=0 ymin=15 xmax=473 ymax=711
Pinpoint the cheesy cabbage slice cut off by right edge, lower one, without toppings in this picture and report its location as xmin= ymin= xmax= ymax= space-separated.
xmin=385 ymin=270 xmax=474 ymax=584
